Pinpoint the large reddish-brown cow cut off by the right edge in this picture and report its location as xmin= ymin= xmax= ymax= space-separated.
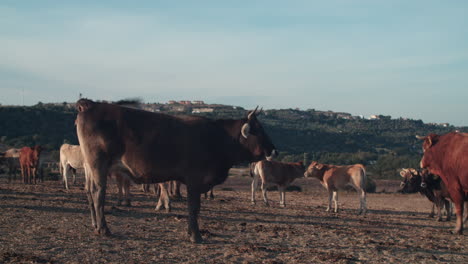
xmin=418 ymin=132 xmax=468 ymax=234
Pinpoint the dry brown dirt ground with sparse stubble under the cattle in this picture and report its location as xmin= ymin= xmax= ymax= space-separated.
xmin=0 ymin=170 xmax=468 ymax=263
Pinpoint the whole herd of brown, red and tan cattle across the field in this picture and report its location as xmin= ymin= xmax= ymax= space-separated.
xmin=0 ymin=99 xmax=468 ymax=242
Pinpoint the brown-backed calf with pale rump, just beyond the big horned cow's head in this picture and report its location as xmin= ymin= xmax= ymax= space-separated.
xmin=251 ymin=160 xmax=305 ymax=207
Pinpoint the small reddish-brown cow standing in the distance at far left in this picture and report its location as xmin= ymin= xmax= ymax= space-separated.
xmin=19 ymin=146 xmax=42 ymax=184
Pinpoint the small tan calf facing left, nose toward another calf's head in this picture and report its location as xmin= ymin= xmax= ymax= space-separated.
xmin=304 ymin=161 xmax=367 ymax=214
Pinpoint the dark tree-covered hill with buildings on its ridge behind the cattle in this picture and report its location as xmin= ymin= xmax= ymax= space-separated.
xmin=0 ymin=101 xmax=462 ymax=178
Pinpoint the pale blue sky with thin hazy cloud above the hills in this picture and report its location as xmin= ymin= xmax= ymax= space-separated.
xmin=0 ymin=0 xmax=468 ymax=126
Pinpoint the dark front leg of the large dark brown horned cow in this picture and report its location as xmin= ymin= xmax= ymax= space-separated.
xmin=187 ymin=186 xmax=203 ymax=243
